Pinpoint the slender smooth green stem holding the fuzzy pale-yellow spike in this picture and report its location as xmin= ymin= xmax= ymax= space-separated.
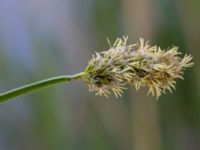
xmin=0 ymin=72 xmax=85 ymax=103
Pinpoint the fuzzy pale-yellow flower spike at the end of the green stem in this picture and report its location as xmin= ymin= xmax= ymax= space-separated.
xmin=84 ymin=37 xmax=193 ymax=98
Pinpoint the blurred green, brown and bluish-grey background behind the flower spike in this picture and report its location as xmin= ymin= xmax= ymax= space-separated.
xmin=0 ymin=0 xmax=200 ymax=150
